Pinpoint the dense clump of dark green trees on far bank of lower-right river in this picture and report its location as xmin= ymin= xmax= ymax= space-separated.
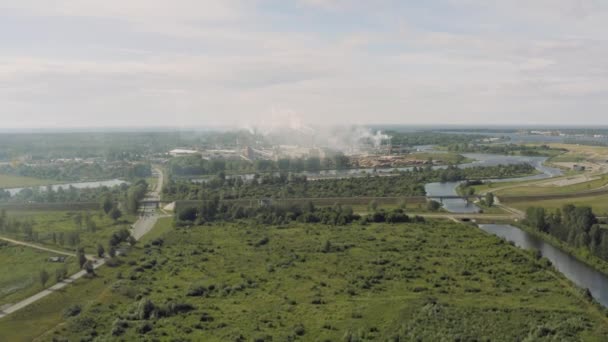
xmin=526 ymin=204 xmax=608 ymax=261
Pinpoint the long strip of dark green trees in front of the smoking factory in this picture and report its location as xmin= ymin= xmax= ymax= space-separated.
xmin=163 ymin=164 xmax=535 ymax=201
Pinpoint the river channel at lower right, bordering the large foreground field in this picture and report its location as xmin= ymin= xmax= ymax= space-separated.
xmin=479 ymin=224 xmax=608 ymax=307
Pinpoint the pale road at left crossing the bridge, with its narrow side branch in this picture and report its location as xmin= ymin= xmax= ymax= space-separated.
xmin=0 ymin=169 xmax=170 ymax=319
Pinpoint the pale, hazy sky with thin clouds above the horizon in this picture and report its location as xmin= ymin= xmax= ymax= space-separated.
xmin=0 ymin=0 xmax=608 ymax=128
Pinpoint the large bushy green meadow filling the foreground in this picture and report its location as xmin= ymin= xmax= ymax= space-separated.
xmin=0 ymin=220 xmax=608 ymax=341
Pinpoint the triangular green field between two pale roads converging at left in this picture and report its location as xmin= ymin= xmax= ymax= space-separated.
xmin=0 ymin=241 xmax=78 ymax=306
